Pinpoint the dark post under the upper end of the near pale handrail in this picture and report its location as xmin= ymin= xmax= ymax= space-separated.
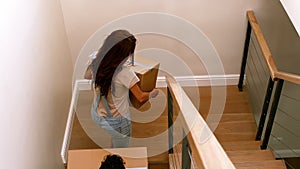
xmin=167 ymin=88 xmax=173 ymax=154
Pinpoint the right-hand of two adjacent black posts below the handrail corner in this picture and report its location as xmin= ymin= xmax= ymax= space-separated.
xmin=260 ymin=79 xmax=284 ymax=150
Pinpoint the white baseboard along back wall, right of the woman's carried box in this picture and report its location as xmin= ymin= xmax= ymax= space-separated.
xmin=156 ymin=74 xmax=240 ymax=87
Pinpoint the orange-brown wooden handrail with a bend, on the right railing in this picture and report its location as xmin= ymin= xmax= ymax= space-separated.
xmin=247 ymin=11 xmax=300 ymax=84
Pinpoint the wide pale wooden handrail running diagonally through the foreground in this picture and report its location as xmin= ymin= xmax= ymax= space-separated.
xmin=166 ymin=76 xmax=235 ymax=169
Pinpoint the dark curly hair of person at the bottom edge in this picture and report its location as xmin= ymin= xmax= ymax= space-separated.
xmin=99 ymin=154 xmax=125 ymax=169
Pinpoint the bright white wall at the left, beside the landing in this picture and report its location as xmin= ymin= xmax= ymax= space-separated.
xmin=0 ymin=0 xmax=72 ymax=169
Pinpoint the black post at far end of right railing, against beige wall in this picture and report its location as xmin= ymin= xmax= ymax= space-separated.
xmin=238 ymin=21 xmax=252 ymax=91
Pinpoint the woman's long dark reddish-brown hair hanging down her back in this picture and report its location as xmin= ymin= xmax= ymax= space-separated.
xmin=91 ymin=30 xmax=136 ymax=96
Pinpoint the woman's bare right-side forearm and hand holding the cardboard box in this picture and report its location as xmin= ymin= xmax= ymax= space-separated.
xmin=130 ymin=83 xmax=159 ymax=103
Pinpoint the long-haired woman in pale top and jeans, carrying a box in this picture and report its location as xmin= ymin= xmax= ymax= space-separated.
xmin=85 ymin=30 xmax=158 ymax=148
